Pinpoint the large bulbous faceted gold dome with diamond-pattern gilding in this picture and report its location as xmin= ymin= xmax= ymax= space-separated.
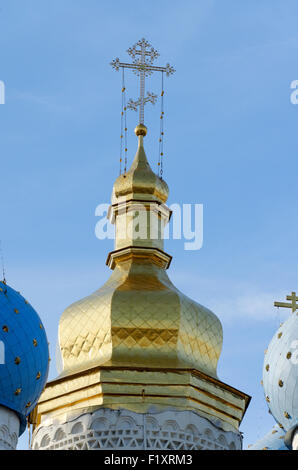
xmin=59 ymin=261 xmax=222 ymax=376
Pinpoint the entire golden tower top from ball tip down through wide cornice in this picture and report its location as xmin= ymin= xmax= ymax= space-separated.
xmin=31 ymin=126 xmax=249 ymax=436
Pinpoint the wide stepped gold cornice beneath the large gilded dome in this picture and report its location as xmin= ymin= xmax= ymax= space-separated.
xmin=31 ymin=366 xmax=250 ymax=429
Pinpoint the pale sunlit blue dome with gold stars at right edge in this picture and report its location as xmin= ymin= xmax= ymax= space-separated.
xmin=263 ymin=313 xmax=298 ymax=431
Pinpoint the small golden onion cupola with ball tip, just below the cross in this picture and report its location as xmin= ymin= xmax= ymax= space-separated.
xmin=112 ymin=124 xmax=169 ymax=204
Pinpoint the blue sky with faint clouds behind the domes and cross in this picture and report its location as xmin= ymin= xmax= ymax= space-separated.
xmin=0 ymin=0 xmax=298 ymax=448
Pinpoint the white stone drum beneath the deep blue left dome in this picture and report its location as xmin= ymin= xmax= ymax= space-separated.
xmin=0 ymin=406 xmax=20 ymax=450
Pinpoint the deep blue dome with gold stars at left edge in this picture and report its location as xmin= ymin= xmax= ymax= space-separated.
xmin=0 ymin=282 xmax=49 ymax=435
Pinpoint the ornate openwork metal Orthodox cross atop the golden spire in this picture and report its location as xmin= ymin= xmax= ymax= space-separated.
xmin=111 ymin=38 xmax=175 ymax=124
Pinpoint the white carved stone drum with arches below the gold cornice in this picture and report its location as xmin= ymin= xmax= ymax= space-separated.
xmin=32 ymin=408 xmax=242 ymax=450
